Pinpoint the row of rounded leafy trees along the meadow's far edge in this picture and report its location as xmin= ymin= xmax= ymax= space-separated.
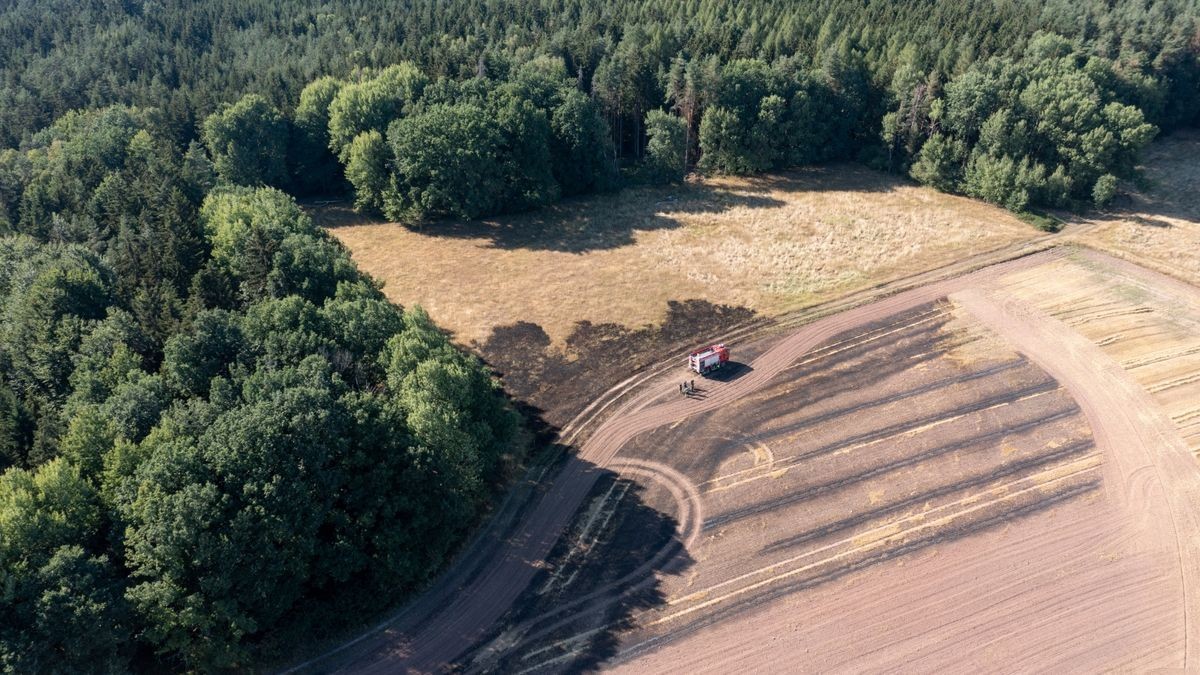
xmin=180 ymin=34 xmax=1170 ymax=222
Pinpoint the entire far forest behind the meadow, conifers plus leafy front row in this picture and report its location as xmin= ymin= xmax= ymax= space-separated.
xmin=0 ymin=0 xmax=1200 ymax=221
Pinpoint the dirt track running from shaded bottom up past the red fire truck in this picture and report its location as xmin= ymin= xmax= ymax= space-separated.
xmin=314 ymin=251 xmax=1058 ymax=673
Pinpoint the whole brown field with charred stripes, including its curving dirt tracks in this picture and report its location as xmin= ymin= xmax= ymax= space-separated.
xmin=300 ymin=250 xmax=1200 ymax=673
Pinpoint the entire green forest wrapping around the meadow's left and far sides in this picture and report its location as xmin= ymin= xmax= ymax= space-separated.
xmin=0 ymin=0 xmax=1200 ymax=673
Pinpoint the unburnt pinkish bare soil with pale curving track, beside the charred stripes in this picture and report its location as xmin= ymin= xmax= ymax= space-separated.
xmin=617 ymin=289 xmax=1200 ymax=673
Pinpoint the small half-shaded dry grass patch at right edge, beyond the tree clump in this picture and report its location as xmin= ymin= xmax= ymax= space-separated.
xmin=1080 ymin=130 xmax=1200 ymax=283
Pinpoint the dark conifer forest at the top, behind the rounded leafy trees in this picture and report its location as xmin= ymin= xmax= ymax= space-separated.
xmin=0 ymin=0 xmax=1196 ymax=150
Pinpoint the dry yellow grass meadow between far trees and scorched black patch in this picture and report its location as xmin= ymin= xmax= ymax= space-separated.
xmin=314 ymin=160 xmax=1037 ymax=344
